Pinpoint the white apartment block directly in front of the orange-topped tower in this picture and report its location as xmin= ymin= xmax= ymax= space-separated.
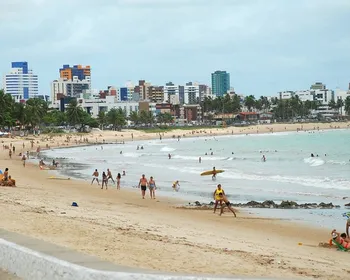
xmin=51 ymin=76 xmax=91 ymax=102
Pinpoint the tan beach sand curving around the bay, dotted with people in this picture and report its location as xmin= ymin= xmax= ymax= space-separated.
xmin=0 ymin=123 xmax=350 ymax=279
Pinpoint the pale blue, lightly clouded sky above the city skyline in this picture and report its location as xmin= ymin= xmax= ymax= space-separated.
xmin=0 ymin=0 xmax=350 ymax=96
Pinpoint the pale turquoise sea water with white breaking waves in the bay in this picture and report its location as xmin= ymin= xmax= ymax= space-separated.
xmin=44 ymin=130 xmax=350 ymax=230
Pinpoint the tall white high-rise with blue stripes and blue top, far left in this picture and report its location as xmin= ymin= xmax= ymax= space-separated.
xmin=3 ymin=61 xmax=39 ymax=102
